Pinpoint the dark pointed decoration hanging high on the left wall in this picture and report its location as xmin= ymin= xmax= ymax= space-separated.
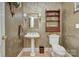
xmin=8 ymin=2 xmax=21 ymax=17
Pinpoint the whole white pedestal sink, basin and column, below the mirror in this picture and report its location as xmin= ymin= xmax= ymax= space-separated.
xmin=24 ymin=32 xmax=40 ymax=56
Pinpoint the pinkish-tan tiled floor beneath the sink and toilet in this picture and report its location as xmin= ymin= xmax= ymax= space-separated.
xmin=19 ymin=51 xmax=73 ymax=57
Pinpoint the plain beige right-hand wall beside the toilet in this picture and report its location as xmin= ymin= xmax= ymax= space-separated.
xmin=63 ymin=2 xmax=79 ymax=56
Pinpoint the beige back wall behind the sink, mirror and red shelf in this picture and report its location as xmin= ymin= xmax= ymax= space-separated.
xmin=23 ymin=2 xmax=61 ymax=48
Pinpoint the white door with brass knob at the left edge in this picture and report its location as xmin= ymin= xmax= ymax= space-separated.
xmin=0 ymin=2 xmax=6 ymax=57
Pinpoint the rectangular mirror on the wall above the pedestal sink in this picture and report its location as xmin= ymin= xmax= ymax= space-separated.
xmin=27 ymin=13 xmax=40 ymax=29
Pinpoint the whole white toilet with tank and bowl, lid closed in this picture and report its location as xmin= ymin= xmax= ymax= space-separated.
xmin=48 ymin=34 xmax=66 ymax=57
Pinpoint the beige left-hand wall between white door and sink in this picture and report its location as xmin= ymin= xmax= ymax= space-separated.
xmin=5 ymin=3 xmax=23 ymax=57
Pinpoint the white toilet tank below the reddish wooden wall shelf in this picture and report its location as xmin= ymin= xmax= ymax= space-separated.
xmin=48 ymin=34 xmax=59 ymax=45
